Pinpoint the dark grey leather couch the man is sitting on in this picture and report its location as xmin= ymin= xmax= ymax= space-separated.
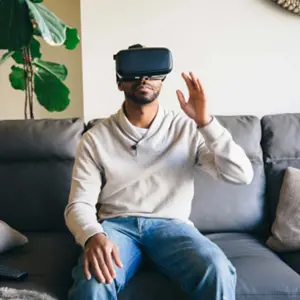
xmin=0 ymin=114 xmax=300 ymax=300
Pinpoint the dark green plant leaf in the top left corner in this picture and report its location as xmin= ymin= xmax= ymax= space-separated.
xmin=0 ymin=0 xmax=33 ymax=50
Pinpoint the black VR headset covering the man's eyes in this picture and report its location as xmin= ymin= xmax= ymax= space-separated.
xmin=113 ymin=48 xmax=173 ymax=81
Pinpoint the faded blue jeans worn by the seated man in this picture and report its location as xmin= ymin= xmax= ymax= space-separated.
xmin=69 ymin=217 xmax=236 ymax=300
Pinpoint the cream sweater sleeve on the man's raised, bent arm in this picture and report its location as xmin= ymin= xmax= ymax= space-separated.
xmin=197 ymin=117 xmax=253 ymax=184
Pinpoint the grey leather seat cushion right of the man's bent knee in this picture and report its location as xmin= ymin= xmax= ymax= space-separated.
xmin=208 ymin=233 xmax=300 ymax=300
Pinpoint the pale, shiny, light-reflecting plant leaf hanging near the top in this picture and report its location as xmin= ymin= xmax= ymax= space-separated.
xmin=25 ymin=0 xmax=67 ymax=46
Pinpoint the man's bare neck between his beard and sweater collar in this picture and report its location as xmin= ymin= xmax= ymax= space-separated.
xmin=124 ymin=99 xmax=158 ymax=128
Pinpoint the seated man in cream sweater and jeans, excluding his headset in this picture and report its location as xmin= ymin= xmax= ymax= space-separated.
xmin=65 ymin=44 xmax=253 ymax=300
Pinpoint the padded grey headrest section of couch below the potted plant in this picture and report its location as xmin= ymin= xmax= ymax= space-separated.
xmin=0 ymin=119 xmax=84 ymax=161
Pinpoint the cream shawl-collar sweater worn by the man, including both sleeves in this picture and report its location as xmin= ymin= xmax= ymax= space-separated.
xmin=65 ymin=106 xmax=253 ymax=246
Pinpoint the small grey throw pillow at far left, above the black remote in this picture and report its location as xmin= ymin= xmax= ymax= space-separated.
xmin=0 ymin=220 xmax=28 ymax=253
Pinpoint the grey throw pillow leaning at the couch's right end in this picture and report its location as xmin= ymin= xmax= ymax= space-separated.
xmin=267 ymin=167 xmax=300 ymax=252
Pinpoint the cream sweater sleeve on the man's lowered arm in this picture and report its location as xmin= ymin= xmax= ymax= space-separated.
xmin=64 ymin=132 xmax=103 ymax=247
